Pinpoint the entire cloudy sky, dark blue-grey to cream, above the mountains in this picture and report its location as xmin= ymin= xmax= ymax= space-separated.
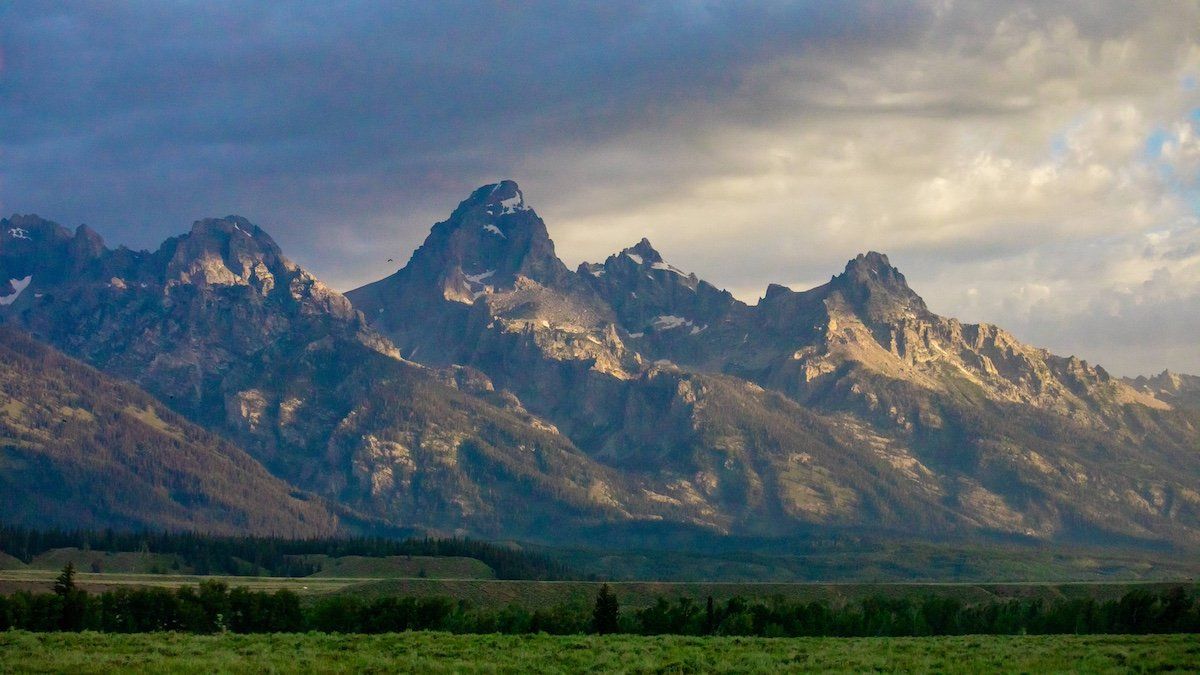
xmin=0 ymin=0 xmax=1200 ymax=375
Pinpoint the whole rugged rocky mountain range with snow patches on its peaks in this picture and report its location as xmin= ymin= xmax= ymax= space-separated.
xmin=0 ymin=180 xmax=1200 ymax=548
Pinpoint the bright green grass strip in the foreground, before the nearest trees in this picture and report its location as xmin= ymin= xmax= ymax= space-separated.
xmin=0 ymin=632 xmax=1200 ymax=673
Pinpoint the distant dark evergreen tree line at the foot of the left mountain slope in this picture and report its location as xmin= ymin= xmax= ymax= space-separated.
xmin=0 ymin=525 xmax=569 ymax=579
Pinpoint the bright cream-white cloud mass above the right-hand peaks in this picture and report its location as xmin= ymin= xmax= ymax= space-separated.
xmin=527 ymin=4 xmax=1200 ymax=372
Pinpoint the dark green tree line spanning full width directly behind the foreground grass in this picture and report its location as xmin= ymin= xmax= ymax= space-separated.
xmin=0 ymin=577 xmax=1200 ymax=637
